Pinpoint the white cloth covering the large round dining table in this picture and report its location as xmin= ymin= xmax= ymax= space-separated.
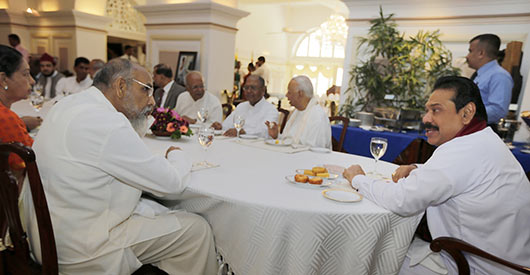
xmin=144 ymin=136 xmax=419 ymax=275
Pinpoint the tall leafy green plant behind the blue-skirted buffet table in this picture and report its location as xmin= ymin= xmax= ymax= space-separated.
xmin=340 ymin=8 xmax=460 ymax=117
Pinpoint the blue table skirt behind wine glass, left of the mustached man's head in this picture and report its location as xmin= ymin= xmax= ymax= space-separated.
xmin=331 ymin=125 xmax=425 ymax=162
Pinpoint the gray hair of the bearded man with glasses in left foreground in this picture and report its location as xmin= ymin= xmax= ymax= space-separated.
xmin=93 ymin=58 xmax=134 ymax=91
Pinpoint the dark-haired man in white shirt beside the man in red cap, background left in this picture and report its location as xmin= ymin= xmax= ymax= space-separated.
xmin=55 ymin=57 xmax=92 ymax=96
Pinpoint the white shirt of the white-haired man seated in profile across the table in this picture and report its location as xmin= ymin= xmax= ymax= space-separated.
xmin=281 ymin=98 xmax=331 ymax=149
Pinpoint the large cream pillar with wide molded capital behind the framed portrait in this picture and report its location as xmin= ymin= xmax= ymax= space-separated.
xmin=136 ymin=2 xmax=249 ymax=99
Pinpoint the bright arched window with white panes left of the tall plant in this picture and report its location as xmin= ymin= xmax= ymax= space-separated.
xmin=290 ymin=15 xmax=348 ymax=96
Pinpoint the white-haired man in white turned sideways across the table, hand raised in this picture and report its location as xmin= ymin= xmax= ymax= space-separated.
xmin=266 ymin=75 xmax=331 ymax=149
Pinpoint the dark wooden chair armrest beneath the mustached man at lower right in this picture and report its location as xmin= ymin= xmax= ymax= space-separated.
xmin=430 ymin=237 xmax=530 ymax=275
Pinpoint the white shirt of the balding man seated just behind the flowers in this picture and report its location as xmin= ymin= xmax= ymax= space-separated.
xmin=175 ymin=91 xmax=223 ymax=123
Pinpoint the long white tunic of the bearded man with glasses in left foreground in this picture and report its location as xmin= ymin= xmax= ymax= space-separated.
xmin=30 ymin=87 xmax=191 ymax=274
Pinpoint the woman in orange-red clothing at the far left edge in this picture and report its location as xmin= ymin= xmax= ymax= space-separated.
xmin=0 ymin=45 xmax=35 ymax=179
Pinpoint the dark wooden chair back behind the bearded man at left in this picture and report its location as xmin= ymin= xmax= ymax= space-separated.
xmin=0 ymin=143 xmax=58 ymax=274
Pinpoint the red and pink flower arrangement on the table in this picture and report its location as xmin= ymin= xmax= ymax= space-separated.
xmin=151 ymin=107 xmax=193 ymax=139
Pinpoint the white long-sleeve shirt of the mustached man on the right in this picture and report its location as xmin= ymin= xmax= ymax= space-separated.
xmin=352 ymin=127 xmax=530 ymax=274
